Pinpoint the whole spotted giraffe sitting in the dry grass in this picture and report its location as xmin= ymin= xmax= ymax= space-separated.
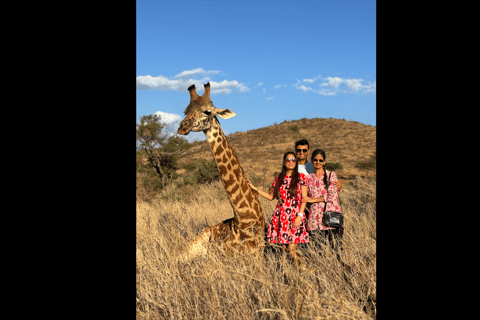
xmin=177 ymin=82 xmax=265 ymax=261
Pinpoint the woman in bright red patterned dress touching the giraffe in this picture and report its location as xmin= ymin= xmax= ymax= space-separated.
xmin=248 ymin=152 xmax=308 ymax=264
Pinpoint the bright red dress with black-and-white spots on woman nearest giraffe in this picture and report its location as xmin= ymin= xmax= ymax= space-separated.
xmin=267 ymin=173 xmax=308 ymax=244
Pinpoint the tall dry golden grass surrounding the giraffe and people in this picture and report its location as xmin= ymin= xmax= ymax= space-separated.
xmin=136 ymin=177 xmax=376 ymax=319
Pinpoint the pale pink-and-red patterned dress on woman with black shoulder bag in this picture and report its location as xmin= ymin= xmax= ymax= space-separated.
xmin=305 ymin=170 xmax=342 ymax=231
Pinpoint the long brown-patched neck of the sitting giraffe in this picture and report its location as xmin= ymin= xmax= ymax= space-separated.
xmin=204 ymin=117 xmax=264 ymax=228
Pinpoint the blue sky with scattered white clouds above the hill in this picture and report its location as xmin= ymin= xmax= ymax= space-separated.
xmin=136 ymin=0 xmax=376 ymax=141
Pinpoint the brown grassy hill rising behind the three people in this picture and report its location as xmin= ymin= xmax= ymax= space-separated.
xmin=178 ymin=118 xmax=376 ymax=186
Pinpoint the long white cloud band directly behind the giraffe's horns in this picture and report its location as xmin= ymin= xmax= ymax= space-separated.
xmin=137 ymin=68 xmax=250 ymax=94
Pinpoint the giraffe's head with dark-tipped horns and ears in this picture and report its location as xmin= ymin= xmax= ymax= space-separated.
xmin=177 ymin=82 xmax=235 ymax=135
